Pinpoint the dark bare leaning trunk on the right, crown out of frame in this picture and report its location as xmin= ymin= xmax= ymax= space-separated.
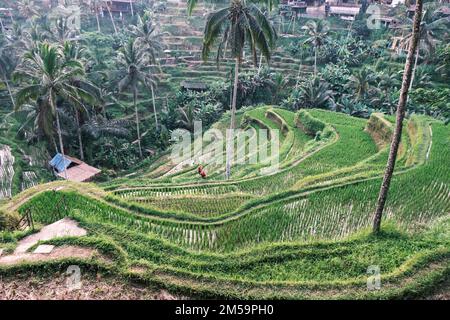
xmin=373 ymin=0 xmax=423 ymax=233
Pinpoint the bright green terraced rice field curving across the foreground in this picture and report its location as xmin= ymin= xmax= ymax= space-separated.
xmin=3 ymin=106 xmax=450 ymax=298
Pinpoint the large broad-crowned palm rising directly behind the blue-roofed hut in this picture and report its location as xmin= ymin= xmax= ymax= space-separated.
xmin=14 ymin=42 xmax=93 ymax=162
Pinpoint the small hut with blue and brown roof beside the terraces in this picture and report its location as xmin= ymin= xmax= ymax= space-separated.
xmin=50 ymin=153 xmax=101 ymax=182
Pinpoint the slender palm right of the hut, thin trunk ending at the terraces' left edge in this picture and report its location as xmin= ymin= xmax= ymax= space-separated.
xmin=117 ymin=40 xmax=155 ymax=158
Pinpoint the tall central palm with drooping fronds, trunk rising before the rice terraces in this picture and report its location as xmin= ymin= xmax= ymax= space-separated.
xmin=202 ymin=0 xmax=277 ymax=179
